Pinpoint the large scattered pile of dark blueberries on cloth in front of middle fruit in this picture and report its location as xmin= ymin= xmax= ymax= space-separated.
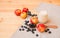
xmin=19 ymin=21 xmax=39 ymax=37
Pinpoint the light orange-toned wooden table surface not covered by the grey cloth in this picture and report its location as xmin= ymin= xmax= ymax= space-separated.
xmin=0 ymin=0 xmax=60 ymax=38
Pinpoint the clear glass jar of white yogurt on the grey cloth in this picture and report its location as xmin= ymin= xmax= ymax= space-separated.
xmin=38 ymin=10 xmax=48 ymax=23
